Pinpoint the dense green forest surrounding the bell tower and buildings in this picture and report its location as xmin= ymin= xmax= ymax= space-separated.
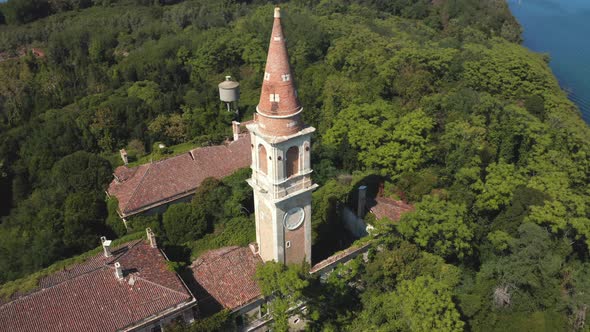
xmin=0 ymin=0 xmax=590 ymax=331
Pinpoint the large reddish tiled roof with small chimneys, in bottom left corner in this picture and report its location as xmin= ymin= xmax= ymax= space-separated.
xmin=0 ymin=241 xmax=194 ymax=332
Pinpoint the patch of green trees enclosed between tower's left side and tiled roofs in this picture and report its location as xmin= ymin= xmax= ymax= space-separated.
xmin=121 ymin=168 xmax=256 ymax=264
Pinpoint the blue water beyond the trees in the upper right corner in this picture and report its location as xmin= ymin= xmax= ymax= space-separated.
xmin=508 ymin=0 xmax=590 ymax=123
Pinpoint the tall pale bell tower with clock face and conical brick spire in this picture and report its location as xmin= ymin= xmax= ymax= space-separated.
xmin=247 ymin=8 xmax=317 ymax=264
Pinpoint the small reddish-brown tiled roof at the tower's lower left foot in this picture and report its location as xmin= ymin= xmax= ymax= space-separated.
xmin=191 ymin=246 xmax=262 ymax=310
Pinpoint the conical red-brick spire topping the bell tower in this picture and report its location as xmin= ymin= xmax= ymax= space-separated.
xmin=256 ymin=8 xmax=302 ymax=136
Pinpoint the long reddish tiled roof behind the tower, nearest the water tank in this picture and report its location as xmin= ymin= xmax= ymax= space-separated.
xmin=108 ymin=134 xmax=252 ymax=216
